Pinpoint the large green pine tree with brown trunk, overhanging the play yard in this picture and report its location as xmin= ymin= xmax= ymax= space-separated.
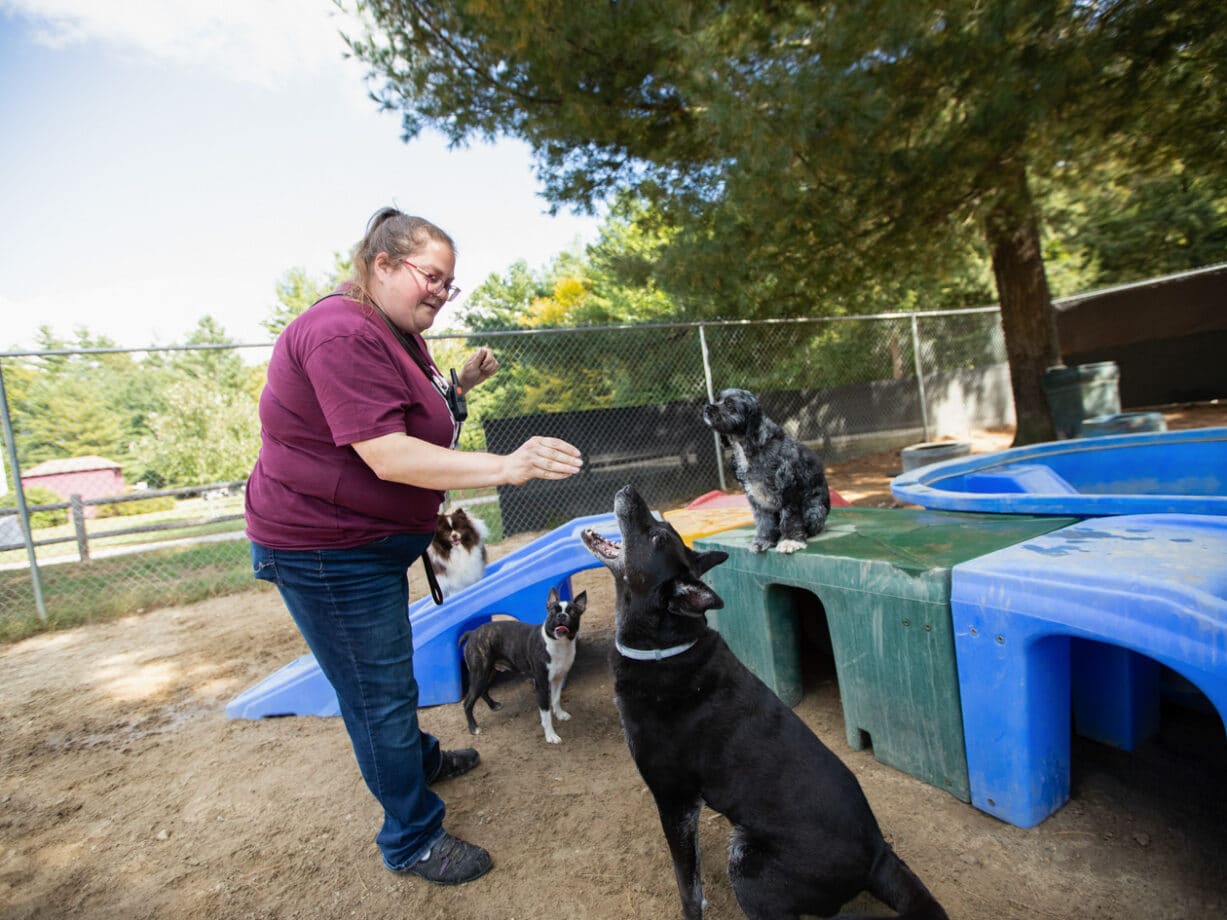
xmin=347 ymin=0 xmax=1227 ymax=439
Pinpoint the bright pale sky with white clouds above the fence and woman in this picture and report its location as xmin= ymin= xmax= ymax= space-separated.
xmin=0 ymin=0 xmax=598 ymax=350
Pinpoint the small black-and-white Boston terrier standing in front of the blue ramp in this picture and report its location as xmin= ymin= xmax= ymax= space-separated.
xmin=460 ymin=588 xmax=588 ymax=745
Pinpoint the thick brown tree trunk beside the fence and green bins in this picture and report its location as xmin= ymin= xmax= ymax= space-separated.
xmin=984 ymin=162 xmax=1061 ymax=447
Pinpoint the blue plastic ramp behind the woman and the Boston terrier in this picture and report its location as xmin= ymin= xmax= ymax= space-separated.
xmin=226 ymin=514 xmax=620 ymax=719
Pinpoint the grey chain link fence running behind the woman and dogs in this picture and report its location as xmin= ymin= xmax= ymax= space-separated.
xmin=0 ymin=308 xmax=1012 ymax=639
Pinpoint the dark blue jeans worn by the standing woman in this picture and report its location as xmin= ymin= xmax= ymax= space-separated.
xmin=252 ymin=534 xmax=444 ymax=870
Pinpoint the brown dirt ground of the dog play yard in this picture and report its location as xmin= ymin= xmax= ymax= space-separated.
xmin=0 ymin=405 xmax=1227 ymax=920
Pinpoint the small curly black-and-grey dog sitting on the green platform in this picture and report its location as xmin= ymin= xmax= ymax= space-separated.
xmin=703 ymin=389 xmax=831 ymax=553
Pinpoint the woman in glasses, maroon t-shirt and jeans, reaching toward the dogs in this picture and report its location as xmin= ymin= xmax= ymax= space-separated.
xmin=247 ymin=207 xmax=582 ymax=884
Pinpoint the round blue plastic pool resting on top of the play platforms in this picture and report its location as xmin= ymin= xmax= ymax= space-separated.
xmin=891 ymin=428 xmax=1227 ymax=518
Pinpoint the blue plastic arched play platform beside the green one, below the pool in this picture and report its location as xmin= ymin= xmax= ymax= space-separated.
xmin=951 ymin=514 xmax=1227 ymax=827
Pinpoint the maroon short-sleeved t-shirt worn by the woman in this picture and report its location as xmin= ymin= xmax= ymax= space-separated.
xmin=247 ymin=294 xmax=455 ymax=550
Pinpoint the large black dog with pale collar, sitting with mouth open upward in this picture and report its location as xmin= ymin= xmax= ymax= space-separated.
xmin=583 ymin=486 xmax=946 ymax=920
